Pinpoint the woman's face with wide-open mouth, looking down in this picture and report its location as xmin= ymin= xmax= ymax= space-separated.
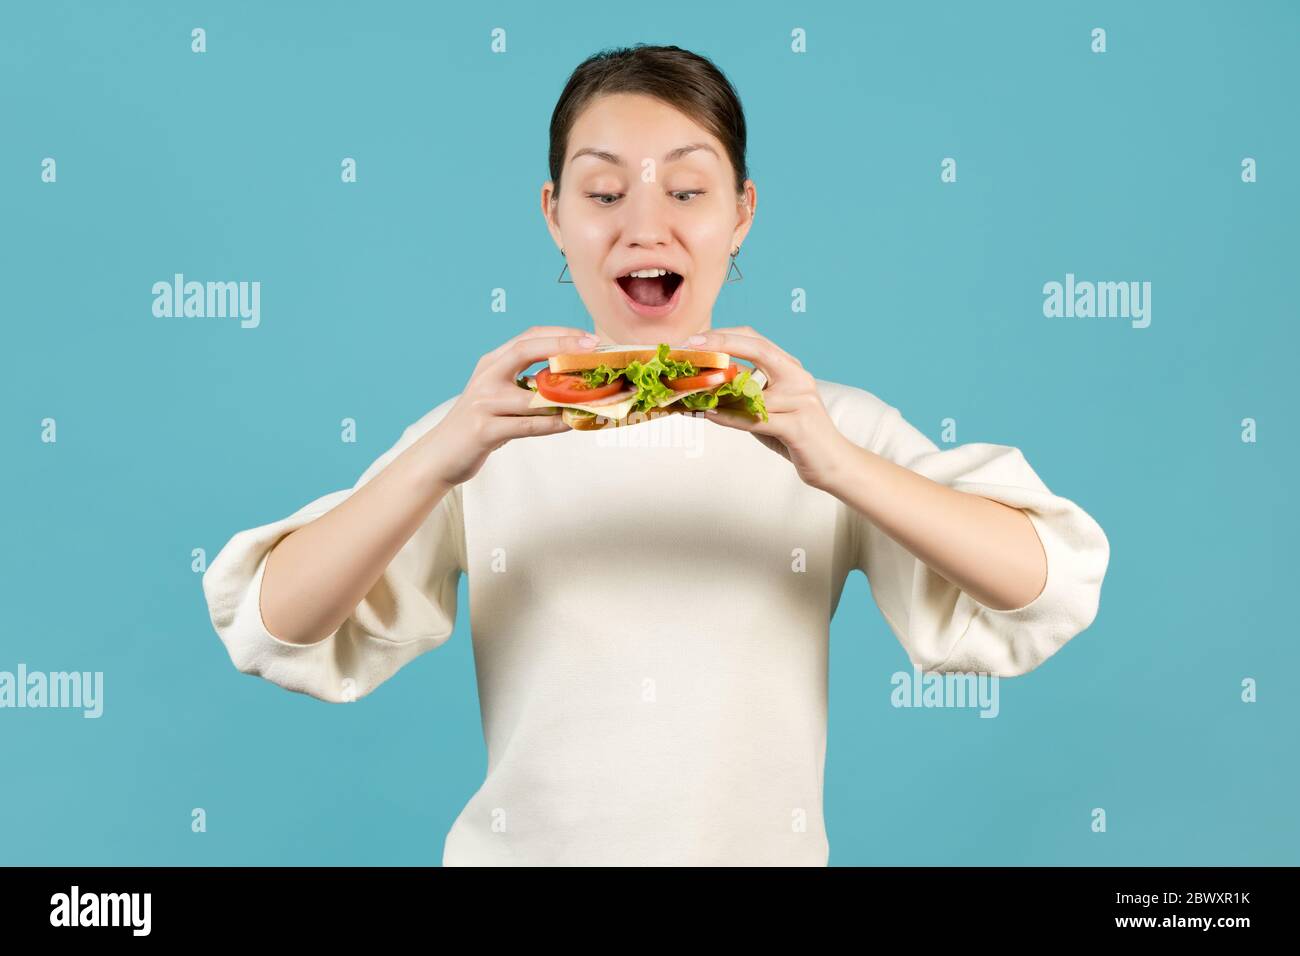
xmin=542 ymin=94 xmax=757 ymax=345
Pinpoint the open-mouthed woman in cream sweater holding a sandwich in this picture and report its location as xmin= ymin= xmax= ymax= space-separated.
xmin=203 ymin=46 xmax=1109 ymax=865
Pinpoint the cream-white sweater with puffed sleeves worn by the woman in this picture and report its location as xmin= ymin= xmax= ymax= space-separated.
xmin=203 ymin=380 xmax=1110 ymax=866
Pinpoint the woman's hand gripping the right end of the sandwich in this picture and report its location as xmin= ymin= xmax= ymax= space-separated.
xmin=679 ymin=325 xmax=848 ymax=490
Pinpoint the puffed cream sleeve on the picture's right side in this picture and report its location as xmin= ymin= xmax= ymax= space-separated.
xmin=850 ymin=406 xmax=1110 ymax=678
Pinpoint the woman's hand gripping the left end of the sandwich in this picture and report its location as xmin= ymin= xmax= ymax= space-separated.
xmin=419 ymin=325 xmax=598 ymax=486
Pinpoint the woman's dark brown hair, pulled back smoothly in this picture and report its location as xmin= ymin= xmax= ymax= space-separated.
xmin=550 ymin=43 xmax=749 ymax=196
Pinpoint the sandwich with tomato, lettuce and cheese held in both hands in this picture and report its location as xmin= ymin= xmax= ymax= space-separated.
xmin=515 ymin=342 xmax=767 ymax=431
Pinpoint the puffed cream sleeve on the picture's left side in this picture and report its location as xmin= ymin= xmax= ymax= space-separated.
xmin=203 ymin=398 xmax=465 ymax=704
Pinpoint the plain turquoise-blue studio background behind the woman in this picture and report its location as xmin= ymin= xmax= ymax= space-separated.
xmin=0 ymin=3 xmax=1300 ymax=865
